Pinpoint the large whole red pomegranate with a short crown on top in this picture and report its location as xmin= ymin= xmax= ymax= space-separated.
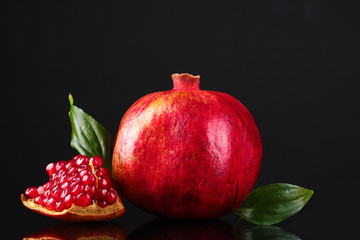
xmin=113 ymin=74 xmax=262 ymax=219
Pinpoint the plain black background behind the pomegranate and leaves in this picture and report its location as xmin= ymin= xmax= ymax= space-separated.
xmin=1 ymin=0 xmax=360 ymax=239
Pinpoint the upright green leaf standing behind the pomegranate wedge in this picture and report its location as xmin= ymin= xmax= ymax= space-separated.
xmin=69 ymin=94 xmax=113 ymax=173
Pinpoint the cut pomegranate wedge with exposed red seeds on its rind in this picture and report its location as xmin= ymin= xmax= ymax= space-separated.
xmin=21 ymin=155 xmax=125 ymax=222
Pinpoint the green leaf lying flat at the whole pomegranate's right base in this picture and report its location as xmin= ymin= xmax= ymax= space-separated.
xmin=234 ymin=183 xmax=313 ymax=225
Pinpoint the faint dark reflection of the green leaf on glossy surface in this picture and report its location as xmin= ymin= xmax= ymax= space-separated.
xmin=236 ymin=226 xmax=301 ymax=240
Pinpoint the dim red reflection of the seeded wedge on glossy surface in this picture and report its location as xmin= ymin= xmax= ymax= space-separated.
xmin=23 ymin=222 xmax=126 ymax=240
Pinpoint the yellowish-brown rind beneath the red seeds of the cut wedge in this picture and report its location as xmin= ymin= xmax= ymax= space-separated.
xmin=21 ymin=194 xmax=125 ymax=222
